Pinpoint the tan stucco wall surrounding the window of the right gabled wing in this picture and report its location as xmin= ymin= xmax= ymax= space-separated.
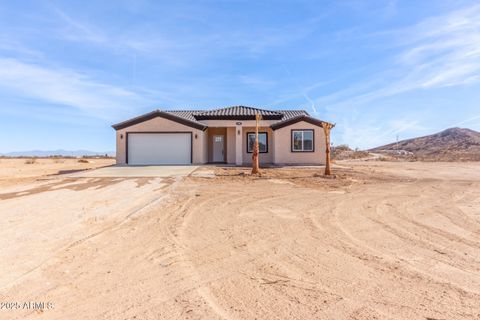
xmin=274 ymin=121 xmax=325 ymax=164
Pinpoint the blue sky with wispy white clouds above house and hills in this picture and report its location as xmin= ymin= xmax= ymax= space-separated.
xmin=0 ymin=0 xmax=480 ymax=153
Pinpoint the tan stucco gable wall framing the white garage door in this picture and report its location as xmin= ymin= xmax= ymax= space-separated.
xmin=116 ymin=117 xmax=207 ymax=164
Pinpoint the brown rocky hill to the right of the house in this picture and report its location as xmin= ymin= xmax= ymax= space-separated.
xmin=369 ymin=128 xmax=480 ymax=161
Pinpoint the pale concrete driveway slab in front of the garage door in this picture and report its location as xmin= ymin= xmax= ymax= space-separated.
xmin=69 ymin=166 xmax=198 ymax=178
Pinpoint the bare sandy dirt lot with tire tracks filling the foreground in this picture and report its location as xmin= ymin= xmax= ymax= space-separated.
xmin=0 ymin=160 xmax=480 ymax=320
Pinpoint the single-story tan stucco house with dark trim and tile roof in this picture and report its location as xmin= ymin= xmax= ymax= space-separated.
xmin=112 ymin=106 xmax=325 ymax=165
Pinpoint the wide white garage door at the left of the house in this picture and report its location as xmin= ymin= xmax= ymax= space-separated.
xmin=128 ymin=133 xmax=192 ymax=165
